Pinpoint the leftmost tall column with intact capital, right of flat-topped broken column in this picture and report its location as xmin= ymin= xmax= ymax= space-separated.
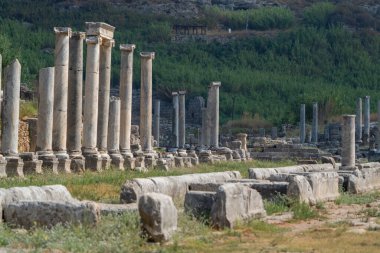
xmin=53 ymin=27 xmax=71 ymax=172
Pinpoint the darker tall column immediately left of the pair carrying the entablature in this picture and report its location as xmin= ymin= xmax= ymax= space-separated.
xmin=67 ymin=32 xmax=86 ymax=172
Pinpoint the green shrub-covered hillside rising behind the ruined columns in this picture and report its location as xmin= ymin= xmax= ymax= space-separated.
xmin=0 ymin=0 xmax=380 ymax=124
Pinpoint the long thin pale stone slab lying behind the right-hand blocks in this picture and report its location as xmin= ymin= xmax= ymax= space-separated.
xmin=249 ymin=163 xmax=334 ymax=181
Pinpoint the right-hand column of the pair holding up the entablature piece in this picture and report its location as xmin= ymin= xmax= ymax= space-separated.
xmin=97 ymin=39 xmax=115 ymax=168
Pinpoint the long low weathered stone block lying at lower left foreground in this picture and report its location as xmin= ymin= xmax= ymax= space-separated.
xmin=4 ymin=201 xmax=100 ymax=229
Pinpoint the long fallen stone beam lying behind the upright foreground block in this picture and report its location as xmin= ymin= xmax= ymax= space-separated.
xmin=120 ymin=171 xmax=241 ymax=203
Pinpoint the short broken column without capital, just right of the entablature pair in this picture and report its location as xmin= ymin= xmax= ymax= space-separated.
xmin=107 ymin=97 xmax=124 ymax=170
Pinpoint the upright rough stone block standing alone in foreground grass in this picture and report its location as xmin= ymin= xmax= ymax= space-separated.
xmin=138 ymin=192 xmax=178 ymax=242
